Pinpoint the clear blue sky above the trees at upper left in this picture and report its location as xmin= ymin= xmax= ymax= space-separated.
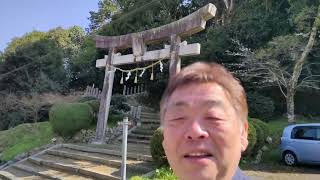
xmin=0 ymin=0 xmax=99 ymax=51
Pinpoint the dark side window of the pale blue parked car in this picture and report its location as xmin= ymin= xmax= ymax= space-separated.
xmin=291 ymin=126 xmax=320 ymax=140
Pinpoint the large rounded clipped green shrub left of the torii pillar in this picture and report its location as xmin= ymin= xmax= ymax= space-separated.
xmin=49 ymin=103 xmax=93 ymax=137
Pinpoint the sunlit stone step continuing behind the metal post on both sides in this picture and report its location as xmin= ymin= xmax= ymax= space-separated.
xmin=47 ymin=148 xmax=154 ymax=174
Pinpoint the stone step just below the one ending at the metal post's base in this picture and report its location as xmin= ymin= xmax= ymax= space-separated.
xmin=17 ymin=160 xmax=92 ymax=180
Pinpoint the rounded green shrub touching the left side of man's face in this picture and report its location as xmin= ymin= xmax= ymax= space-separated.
xmin=150 ymin=128 xmax=169 ymax=166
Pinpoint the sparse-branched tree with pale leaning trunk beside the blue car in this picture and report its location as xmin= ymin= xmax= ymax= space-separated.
xmin=225 ymin=4 xmax=320 ymax=122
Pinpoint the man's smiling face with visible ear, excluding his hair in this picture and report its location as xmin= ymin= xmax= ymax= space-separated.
xmin=163 ymin=83 xmax=248 ymax=180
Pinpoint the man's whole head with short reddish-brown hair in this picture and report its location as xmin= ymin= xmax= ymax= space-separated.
xmin=160 ymin=63 xmax=248 ymax=180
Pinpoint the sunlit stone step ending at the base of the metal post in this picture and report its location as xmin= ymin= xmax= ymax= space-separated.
xmin=30 ymin=154 xmax=120 ymax=180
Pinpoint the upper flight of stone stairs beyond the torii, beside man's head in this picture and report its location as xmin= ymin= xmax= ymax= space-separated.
xmin=124 ymin=107 xmax=160 ymax=146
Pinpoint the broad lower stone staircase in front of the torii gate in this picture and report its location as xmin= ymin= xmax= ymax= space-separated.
xmin=0 ymin=143 xmax=155 ymax=180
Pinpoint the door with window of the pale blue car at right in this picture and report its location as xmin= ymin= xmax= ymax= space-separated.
xmin=292 ymin=126 xmax=320 ymax=162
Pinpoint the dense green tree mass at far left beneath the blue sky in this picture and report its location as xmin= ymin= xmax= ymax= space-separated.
xmin=0 ymin=26 xmax=85 ymax=94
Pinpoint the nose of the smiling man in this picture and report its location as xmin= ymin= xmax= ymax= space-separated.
xmin=185 ymin=120 xmax=209 ymax=140
